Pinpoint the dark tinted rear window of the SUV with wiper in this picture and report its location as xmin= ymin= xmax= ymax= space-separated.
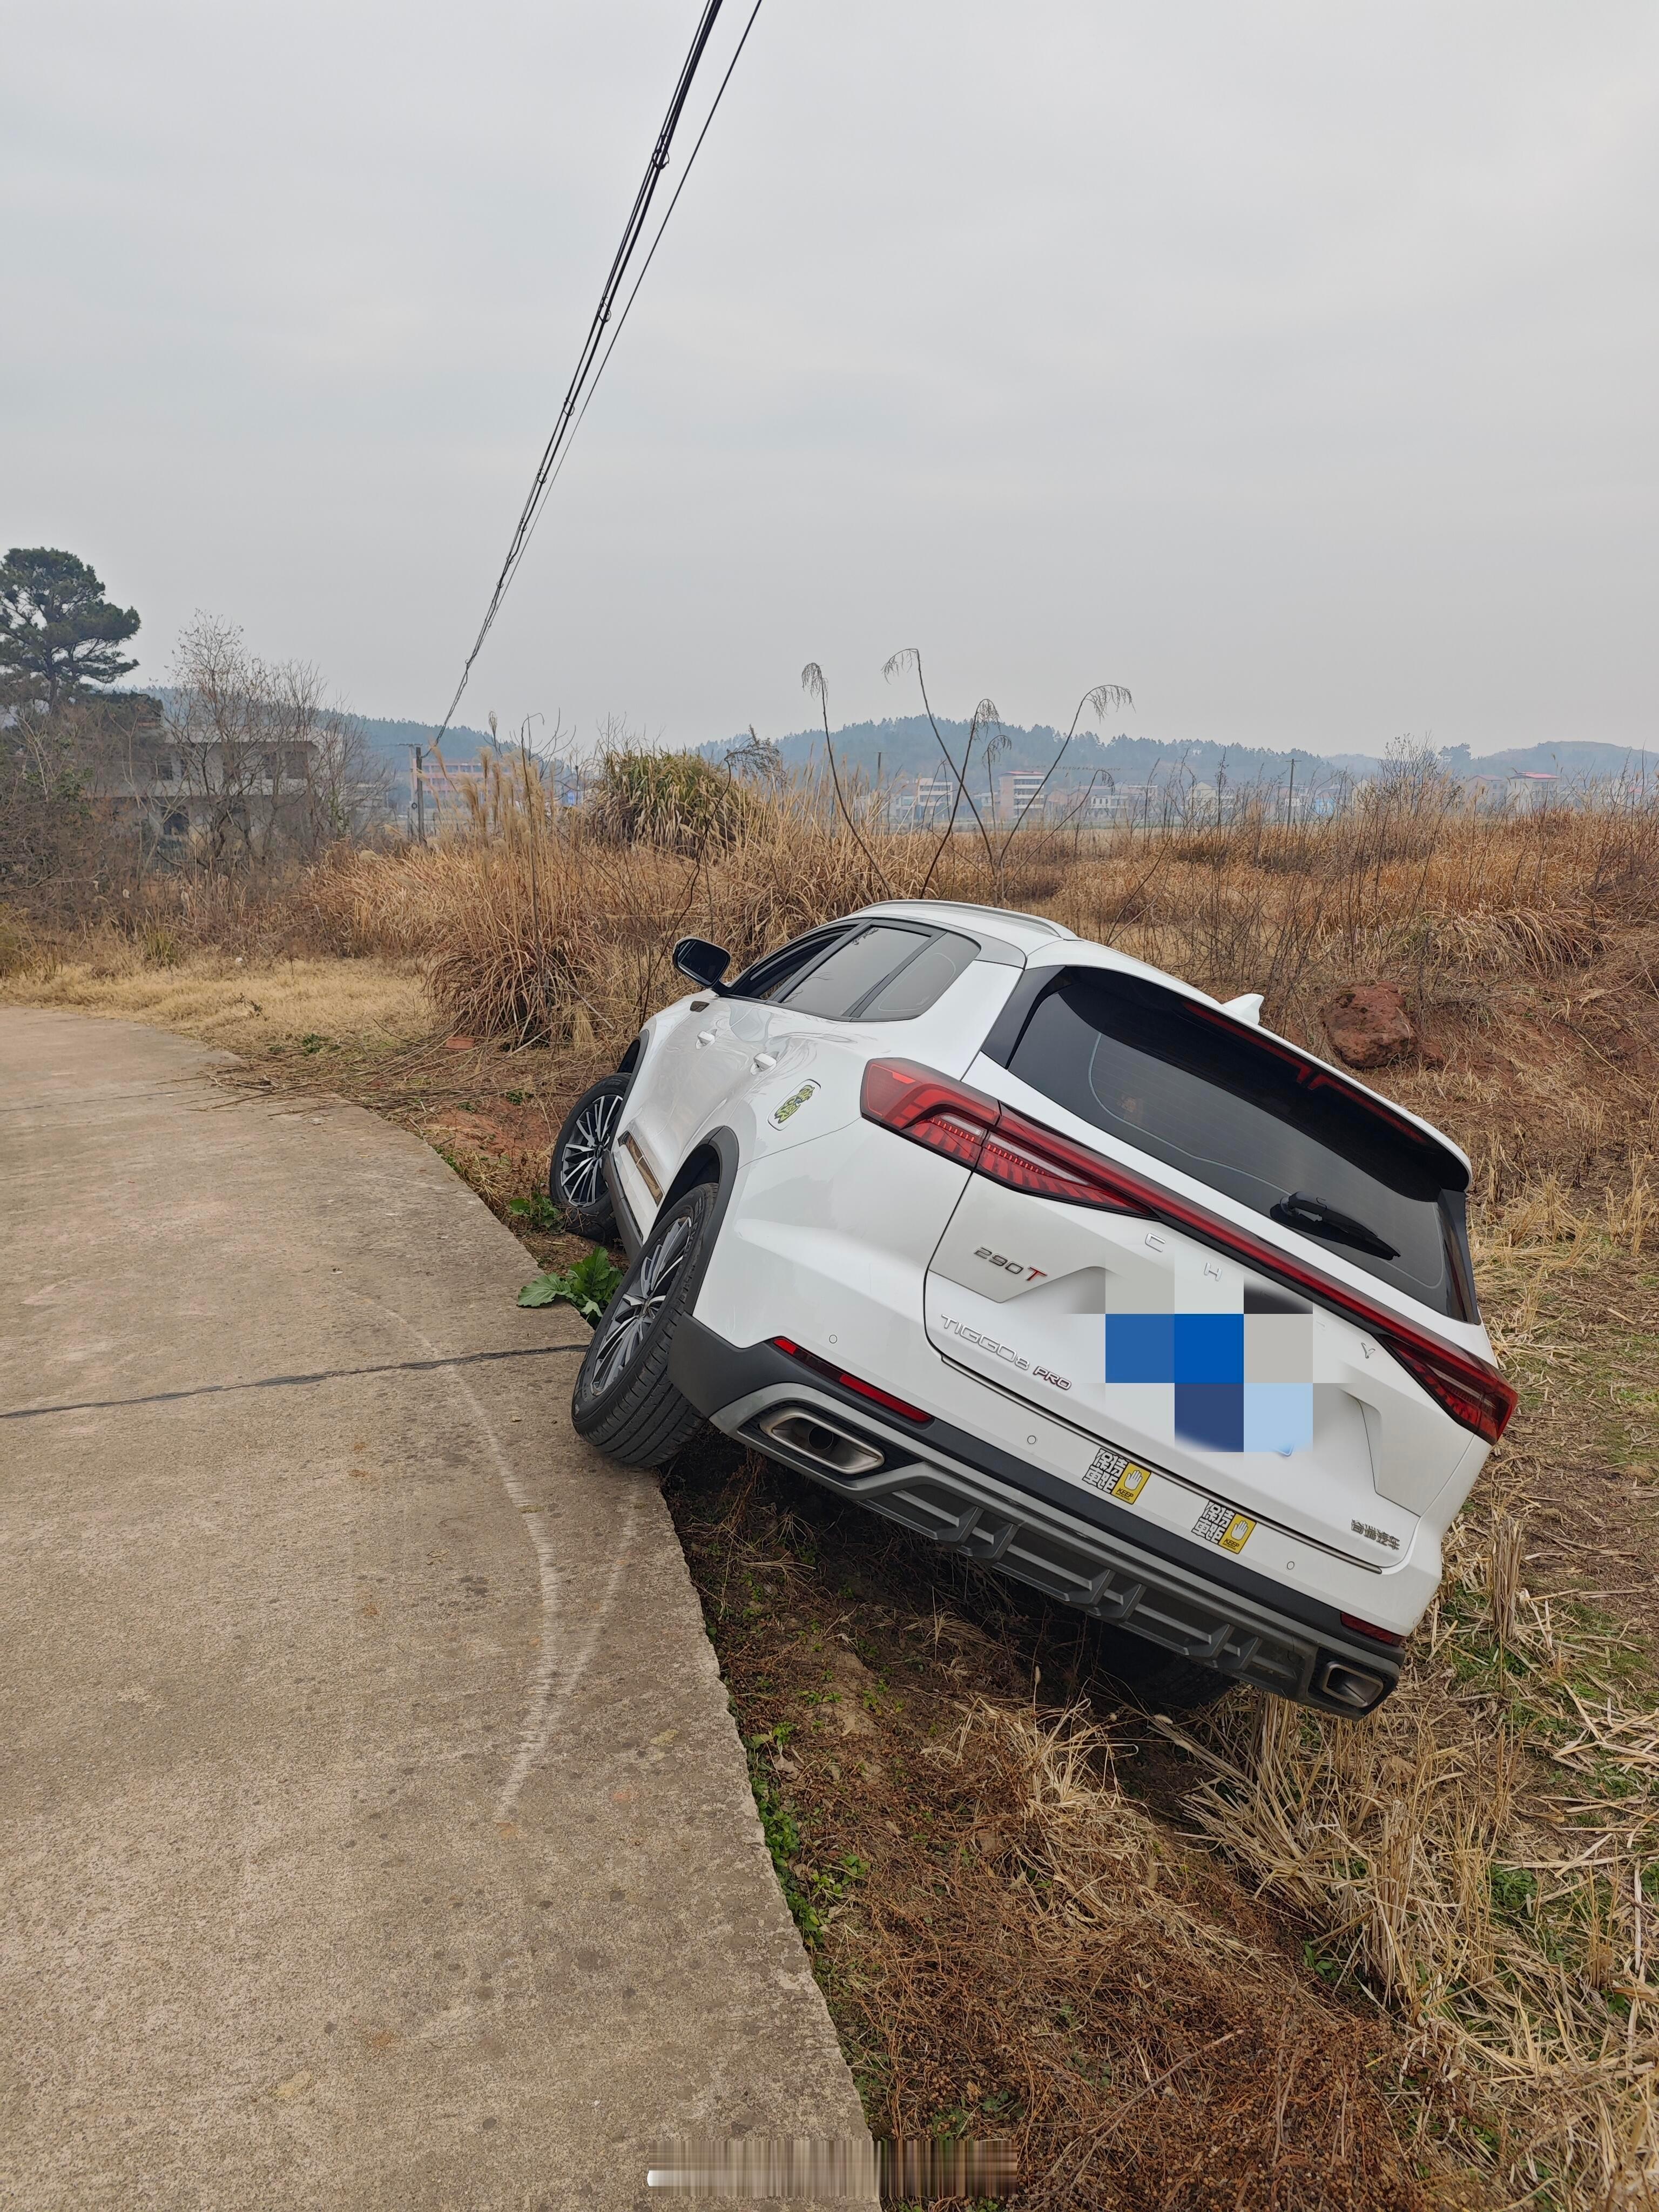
xmin=987 ymin=969 xmax=1475 ymax=1320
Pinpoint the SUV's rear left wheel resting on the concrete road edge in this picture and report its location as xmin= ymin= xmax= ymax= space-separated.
xmin=571 ymin=1183 xmax=714 ymax=1467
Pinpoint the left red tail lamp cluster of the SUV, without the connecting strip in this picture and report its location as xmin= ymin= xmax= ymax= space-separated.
xmin=860 ymin=1060 xmax=1150 ymax=1215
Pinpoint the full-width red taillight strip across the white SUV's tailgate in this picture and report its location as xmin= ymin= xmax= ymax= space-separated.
xmin=860 ymin=1060 xmax=1515 ymax=1445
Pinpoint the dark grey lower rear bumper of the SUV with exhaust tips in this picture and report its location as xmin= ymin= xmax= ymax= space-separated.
xmin=670 ymin=1316 xmax=1400 ymax=1719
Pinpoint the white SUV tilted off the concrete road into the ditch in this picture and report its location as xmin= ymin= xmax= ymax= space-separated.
xmin=551 ymin=900 xmax=1515 ymax=1714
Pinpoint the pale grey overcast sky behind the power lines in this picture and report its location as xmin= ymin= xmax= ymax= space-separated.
xmin=0 ymin=0 xmax=1659 ymax=752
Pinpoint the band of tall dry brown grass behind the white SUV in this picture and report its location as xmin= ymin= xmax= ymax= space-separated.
xmin=285 ymin=770 xmax=1659 ymax=1075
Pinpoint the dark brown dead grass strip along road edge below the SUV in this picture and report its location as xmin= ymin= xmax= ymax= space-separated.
xmin=668 ymin=1445 xmax=1451 ymax=2212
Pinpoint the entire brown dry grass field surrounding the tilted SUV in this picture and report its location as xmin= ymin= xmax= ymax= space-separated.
xmin=0 ymin=772 xmax=1659 ymax=2212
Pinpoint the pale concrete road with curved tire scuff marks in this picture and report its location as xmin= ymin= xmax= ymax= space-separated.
xmin=0 ymin=1011 xmax=862 ymax=2212
